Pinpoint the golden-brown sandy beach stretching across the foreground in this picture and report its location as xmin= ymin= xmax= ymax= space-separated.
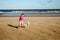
xmin=0 ymin=17 xmax=60 ymax=40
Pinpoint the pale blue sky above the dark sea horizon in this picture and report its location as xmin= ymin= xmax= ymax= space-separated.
xmin=0 ymin=0 xmax=60 ymax=9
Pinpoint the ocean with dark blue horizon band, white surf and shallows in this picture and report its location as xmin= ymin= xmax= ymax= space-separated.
xmin=0 ymin=9 xmax=60 ymax=17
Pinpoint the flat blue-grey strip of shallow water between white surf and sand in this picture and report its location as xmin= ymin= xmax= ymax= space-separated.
xmin=2 ymin=13 xmax=60 ymax=17
